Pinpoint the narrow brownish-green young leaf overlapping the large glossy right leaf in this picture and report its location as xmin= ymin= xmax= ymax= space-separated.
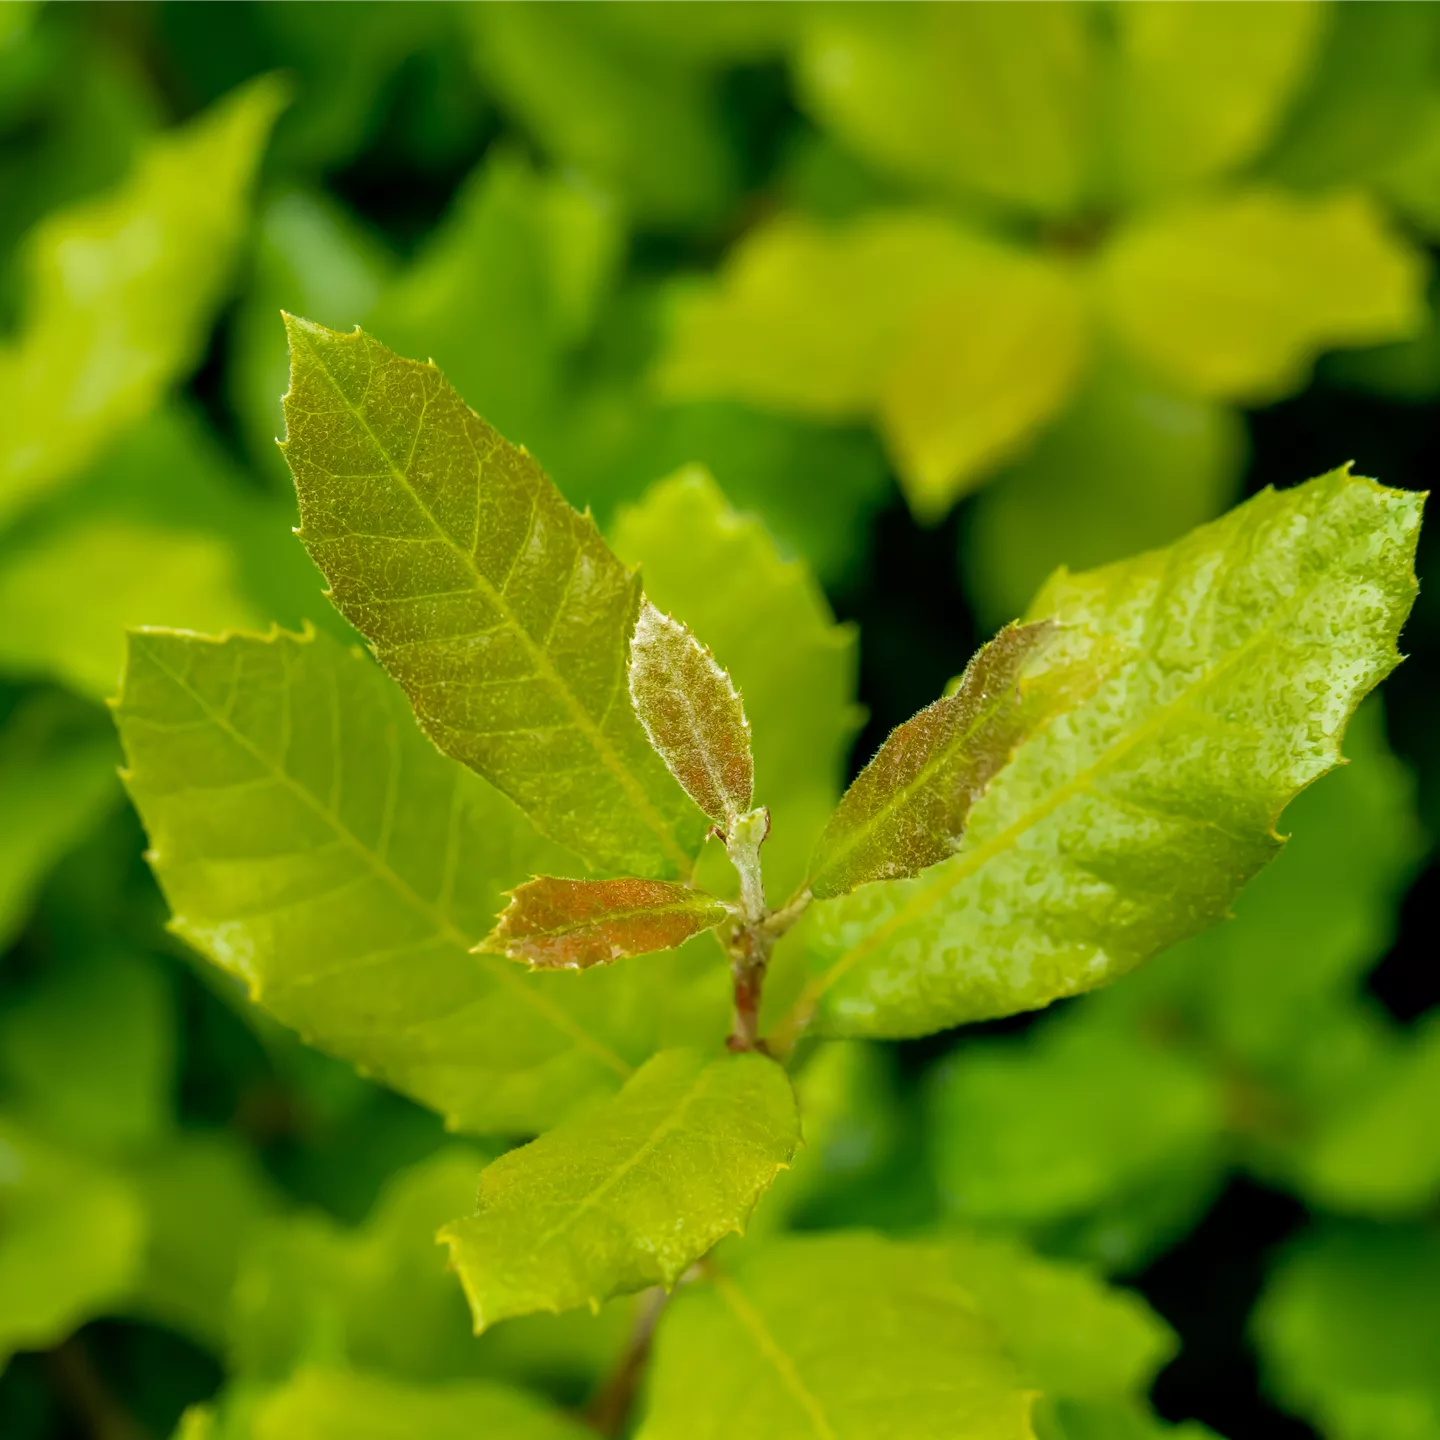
xmin=809 ymin=621 xmax=1056 ymax=899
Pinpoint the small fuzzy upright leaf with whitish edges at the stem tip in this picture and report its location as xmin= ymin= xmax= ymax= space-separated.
xmin=629 ymin=600 xmax=755 ymax=828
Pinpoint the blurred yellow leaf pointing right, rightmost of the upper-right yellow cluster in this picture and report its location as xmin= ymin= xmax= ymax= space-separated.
xmin=1096 ymin=189 xmax=1426 ymax=402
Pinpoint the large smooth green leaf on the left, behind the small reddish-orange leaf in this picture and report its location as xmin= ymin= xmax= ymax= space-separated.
xmin=117 ymin=631 xmax=727 ymax=1133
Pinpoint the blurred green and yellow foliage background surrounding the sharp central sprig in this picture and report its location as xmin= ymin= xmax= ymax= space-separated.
xmin=0 ymin=0 xmax=1440 ymax=1440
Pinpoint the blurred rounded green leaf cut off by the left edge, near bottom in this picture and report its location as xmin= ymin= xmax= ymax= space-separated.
xmin=0 ymin=1117 xmax=145 ymax=1365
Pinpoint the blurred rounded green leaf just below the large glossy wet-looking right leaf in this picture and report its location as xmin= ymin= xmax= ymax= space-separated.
xmin=929 ymin=1015 xmax=1225 ymax=1244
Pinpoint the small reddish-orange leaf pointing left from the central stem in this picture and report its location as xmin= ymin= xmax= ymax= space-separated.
xmin=475 ymin=876 xmax=729 ymax=971
